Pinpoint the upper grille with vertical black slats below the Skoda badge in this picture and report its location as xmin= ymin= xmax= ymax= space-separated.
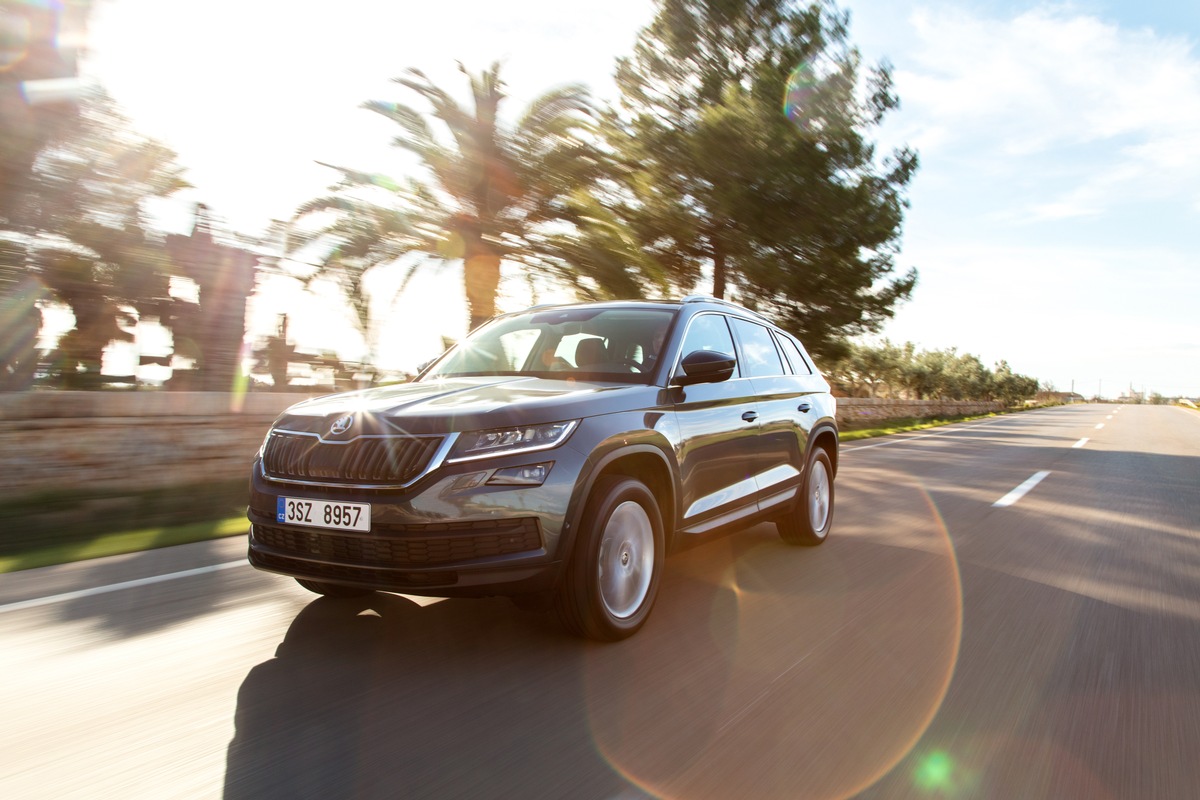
xmin=263 ymin=431 xmax=442 ymax=486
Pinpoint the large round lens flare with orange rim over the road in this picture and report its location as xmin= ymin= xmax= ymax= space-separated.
xmin=586 ymin=474 xmax=962 ymax=800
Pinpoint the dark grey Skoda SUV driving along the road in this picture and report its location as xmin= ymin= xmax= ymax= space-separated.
xmin=248 ymin=297 xmax=838 ymax=639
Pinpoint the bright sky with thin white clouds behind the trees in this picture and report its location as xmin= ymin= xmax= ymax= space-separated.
xmin=84 ymin=0 xmax=1200 ymax=397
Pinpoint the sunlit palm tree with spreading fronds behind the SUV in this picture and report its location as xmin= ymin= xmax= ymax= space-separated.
xmin=293 ymin=64 xmax=600 ymax=329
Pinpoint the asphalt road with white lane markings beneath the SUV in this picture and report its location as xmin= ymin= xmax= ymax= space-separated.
xmin=0 ymin=405 xmax=1200 ymax=800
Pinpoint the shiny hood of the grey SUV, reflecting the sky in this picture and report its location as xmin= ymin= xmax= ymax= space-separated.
xmin=275 ymin=377 xmax=664 ymax=438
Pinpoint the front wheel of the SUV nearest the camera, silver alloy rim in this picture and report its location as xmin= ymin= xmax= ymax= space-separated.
xmin=554 ymin=475 xmax=665 ymax=642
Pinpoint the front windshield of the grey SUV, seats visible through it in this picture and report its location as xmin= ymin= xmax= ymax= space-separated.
xmin=422 ymin=307 xmax=674 ymax=383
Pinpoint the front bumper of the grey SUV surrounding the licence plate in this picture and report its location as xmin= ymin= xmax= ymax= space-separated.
xmin=248 ymin=449 xmax=583 ymax=597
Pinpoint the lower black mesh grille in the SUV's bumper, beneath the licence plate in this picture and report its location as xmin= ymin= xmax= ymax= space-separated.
xmin=254 ymin=517 xmax=541 ymax=569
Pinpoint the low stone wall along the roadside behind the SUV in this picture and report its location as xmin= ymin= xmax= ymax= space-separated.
xmin=0 ymin=391 xmax=1000 ymax=500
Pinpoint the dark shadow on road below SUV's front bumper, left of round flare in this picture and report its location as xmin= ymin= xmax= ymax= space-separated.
xmin=224 ymin=594 xmax=640 ymax=800
